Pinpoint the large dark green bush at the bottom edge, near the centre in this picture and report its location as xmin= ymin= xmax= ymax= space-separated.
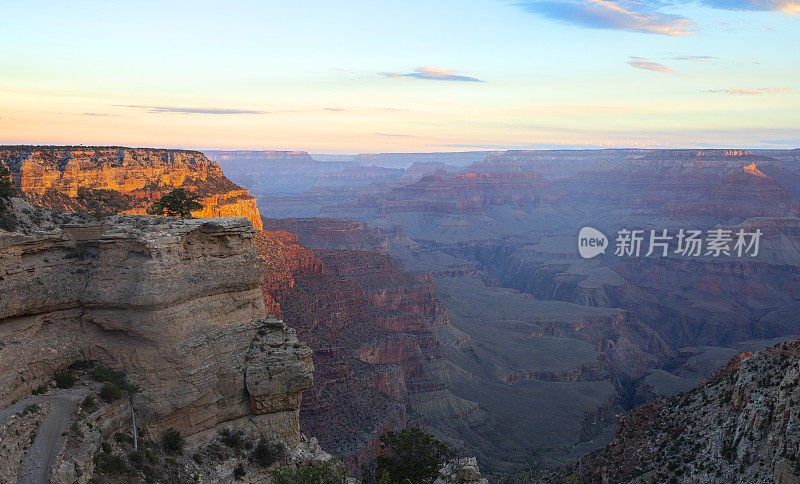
xmin=375 ymin=427 xmax=452 ymax=483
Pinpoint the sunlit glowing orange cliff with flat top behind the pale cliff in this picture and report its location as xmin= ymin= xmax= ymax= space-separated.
xmin=0 ymin=146 xmax=261 ymax=230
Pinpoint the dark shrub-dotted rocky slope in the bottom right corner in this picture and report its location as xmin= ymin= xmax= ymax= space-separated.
xmin=549 ymin=341 xmax=800 ymax=483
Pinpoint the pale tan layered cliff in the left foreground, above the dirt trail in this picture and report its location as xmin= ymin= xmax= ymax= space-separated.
xmin=0 ymin=212 xmax=313 ymax=447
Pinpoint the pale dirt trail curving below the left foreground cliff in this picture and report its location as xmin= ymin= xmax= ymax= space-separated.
xmin=0 ymin=389 xmax=88 ymax=484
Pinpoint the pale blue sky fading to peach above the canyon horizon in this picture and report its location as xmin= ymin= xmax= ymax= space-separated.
xmin=0 ymin=0 xmax=800 ymax=153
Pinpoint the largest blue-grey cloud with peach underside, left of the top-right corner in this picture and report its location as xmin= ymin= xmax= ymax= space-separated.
xmin=516 ymin=0 xmax=696 ymax=35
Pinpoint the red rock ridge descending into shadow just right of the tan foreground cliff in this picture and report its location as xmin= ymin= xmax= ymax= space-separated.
xmin=255 ymin=240 xmax=447 ymax=470
